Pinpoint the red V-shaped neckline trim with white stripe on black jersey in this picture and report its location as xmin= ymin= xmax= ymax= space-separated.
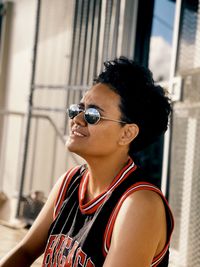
xmin=79 ymin=158 xmax=137 ymax=214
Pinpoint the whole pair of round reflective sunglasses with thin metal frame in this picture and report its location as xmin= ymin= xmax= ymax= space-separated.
xmin=67 ymin=104 xmax=127 ymax=124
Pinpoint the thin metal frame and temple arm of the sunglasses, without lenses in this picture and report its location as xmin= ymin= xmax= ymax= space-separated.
xmin=66 ymin=104 xmax=127 ymax=125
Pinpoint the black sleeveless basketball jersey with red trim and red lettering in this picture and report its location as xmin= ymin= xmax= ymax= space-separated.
xmin=42 ymin=159 xmax=173 ymax=267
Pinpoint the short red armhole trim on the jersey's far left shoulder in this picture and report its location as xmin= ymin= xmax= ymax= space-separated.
xmin=53 ymin=166 xmax=80 ymax=220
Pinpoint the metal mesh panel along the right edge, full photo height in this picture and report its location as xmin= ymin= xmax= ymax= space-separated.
xmin=170 ymin=0 xmax=200 ymax=267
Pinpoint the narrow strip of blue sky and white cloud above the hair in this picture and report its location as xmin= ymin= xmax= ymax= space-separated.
xmin=149 ymin=0 xmax=175 ymax=81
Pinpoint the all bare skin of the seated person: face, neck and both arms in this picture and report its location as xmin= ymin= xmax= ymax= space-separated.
xmin=0 ymin=84 xmax=166 ymax=267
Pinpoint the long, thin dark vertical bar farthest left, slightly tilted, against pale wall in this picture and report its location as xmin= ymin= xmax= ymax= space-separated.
xmin=16 ymin=0 xmax=41 ymax=217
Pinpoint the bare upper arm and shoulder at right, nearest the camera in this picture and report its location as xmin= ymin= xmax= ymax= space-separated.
xmin=104 ymin=190 xmax=166 ymax=267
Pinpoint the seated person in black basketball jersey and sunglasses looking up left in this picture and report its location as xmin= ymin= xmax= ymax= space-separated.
xmin=0 ymin=57 xmax=173 ymax=267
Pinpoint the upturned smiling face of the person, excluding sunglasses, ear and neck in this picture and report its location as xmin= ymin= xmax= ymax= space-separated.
xmin=66 ymin=83 xmax=123 ymax=160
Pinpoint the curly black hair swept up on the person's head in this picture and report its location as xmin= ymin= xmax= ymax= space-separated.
xmin=94 ymin=56 xmax=171 ymax=156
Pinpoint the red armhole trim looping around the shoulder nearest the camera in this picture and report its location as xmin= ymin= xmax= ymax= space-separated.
xmin=103 ymin=182 xmax=174 ymax=267
